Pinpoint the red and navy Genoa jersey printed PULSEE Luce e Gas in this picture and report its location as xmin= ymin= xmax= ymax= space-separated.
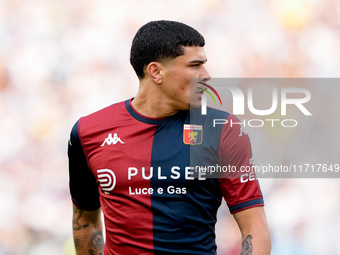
xmin=68 ymin=100 xmax=263 ymax=255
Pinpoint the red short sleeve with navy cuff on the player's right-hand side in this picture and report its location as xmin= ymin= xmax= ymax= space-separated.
xmin=219 ymin=115 xmax=264 ymax=213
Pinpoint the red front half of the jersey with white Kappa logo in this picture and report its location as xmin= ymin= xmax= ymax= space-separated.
xmin=79 ymin=102 xmax=156 ymax=255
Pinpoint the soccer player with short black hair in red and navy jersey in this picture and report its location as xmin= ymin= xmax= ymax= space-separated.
xmin=68 ymin=21 xmax=271 ymax=255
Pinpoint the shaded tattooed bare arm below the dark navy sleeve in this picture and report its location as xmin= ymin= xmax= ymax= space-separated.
xmin=72 ymin=205 xmax=104 ymax=255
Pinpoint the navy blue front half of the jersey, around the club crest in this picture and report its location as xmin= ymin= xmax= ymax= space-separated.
xmin=151 ymin=108 xmax=230 ymax=255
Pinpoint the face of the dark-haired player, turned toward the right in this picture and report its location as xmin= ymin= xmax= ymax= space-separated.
xmin=161 ymin=47 xmax=211 ymax=110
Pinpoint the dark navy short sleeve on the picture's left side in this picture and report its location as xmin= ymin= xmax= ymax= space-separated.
xmin=68 ymin=121 xmax=100 ymax=210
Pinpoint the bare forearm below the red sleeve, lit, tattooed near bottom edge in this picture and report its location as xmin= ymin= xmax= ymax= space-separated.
xmin=234 ymin=206 xmax=271 ymax=255
